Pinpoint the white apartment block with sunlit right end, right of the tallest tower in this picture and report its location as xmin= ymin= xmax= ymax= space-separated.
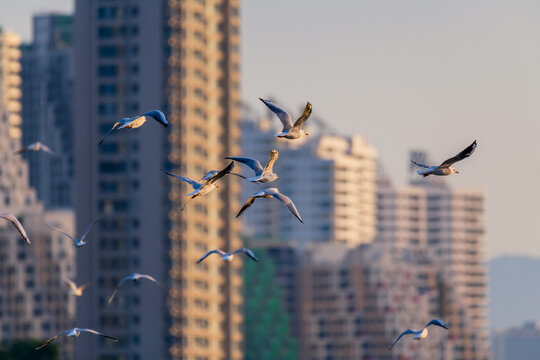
xmin=241 ymin=118 xmax=376 ymax=247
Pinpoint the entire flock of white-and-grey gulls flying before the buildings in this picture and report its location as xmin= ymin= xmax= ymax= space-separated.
xmin=0 ymin=95 xmax=477 ymax=350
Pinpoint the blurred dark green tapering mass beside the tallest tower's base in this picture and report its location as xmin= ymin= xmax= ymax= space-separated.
xmin=244 ymin=250 xmax=298 ymax=360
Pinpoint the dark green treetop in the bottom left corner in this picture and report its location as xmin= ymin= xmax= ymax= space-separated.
xmin=0 ymin=340 xmax=60 ymax=360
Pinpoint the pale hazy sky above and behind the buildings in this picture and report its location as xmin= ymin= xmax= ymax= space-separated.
xmin=0 ymin=0 xmax=540 ymax=257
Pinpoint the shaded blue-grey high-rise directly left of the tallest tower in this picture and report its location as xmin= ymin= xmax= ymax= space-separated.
xmin=21 ymin=14 xmax=75 ymax=208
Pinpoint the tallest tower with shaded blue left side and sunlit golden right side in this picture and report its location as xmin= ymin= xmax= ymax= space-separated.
xmin=75 ymin=0 xmax=243 ymax=360
